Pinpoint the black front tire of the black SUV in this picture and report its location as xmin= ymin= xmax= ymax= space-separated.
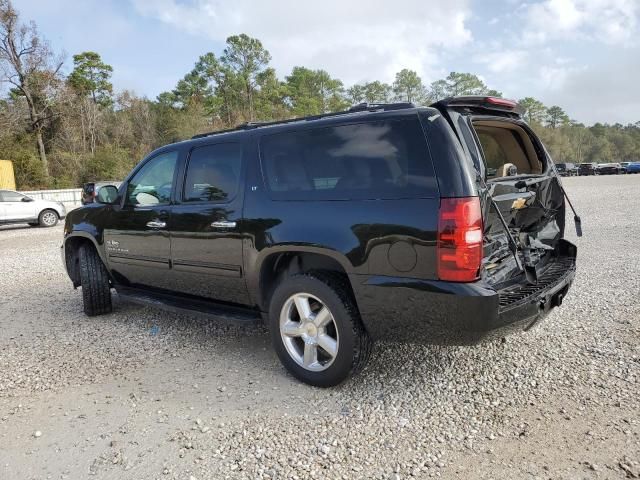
xmin=79 ymin=244 xmax=112 ymax=317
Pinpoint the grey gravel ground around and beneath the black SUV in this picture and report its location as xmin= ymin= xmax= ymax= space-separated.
xmin=0 ymin=175 xmax=640 ymax=480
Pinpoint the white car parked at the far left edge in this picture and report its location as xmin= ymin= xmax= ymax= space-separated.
xmin=0 ymin=190 xmax=67 ymax=227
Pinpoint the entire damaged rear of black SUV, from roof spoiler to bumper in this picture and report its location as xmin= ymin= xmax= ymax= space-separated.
xmin=434 ymin=97 xmax=582 ymax=340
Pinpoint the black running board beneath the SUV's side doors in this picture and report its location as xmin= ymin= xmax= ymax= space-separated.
xmin=116 ymin=286 xmax=262 ymax=324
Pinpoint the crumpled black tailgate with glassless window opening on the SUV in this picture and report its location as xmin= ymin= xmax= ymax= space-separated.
xmin=472 ymin=117 xmax=565 ymax=285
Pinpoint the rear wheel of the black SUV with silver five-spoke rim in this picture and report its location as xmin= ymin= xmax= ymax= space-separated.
xmin=269 ymin=271 xmax=373 ymax=387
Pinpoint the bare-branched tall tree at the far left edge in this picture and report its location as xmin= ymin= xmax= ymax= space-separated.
xmin=0 ymin=0 xmax=62 ymax=180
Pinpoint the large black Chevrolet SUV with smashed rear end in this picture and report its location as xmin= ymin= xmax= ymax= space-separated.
xmin=62 ymin=97 xmax=579 ymax=386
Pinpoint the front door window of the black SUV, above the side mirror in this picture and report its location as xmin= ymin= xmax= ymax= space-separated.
xmin=127 ymin=151 xmax=178 ymax=206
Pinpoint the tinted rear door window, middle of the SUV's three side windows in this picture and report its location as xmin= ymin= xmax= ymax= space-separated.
xmin=184 ymin=143 xmax=242 ymax=202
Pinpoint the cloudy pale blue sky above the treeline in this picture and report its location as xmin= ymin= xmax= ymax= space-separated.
xmin=13 ymin=0 xmax=640 ymax=125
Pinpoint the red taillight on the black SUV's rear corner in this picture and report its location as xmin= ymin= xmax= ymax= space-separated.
xmin=438 ymin=197 xmax=482 ymax=282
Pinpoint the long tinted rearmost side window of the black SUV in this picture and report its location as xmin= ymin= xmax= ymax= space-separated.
xmin=260 ymin=117 xmax=437 ymax=200
